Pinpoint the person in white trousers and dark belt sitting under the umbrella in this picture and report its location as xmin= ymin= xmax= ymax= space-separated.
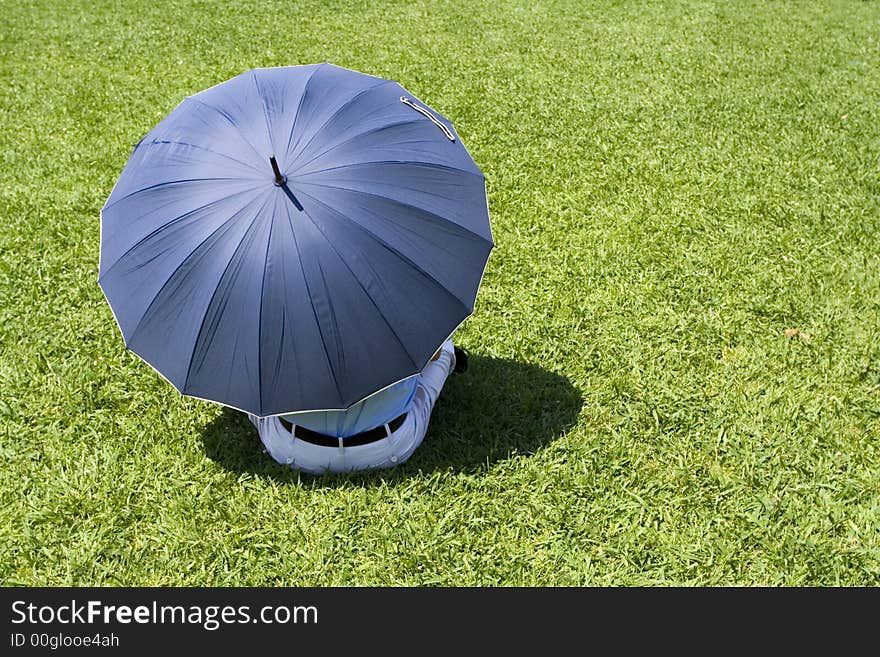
xmin=248 ymin=339 xmax=468 ymax=475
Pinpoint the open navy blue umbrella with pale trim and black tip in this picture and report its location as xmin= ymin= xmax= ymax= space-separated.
xmin=99 ymin=64 xmax=493 ymax=416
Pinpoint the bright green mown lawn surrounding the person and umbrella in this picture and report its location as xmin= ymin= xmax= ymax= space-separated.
xmin=0 ymin=0 xmax=880 ymax=586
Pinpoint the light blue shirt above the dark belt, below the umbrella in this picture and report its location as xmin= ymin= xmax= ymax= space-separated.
xmin=282 ymin=376 xmax=419 ymax=438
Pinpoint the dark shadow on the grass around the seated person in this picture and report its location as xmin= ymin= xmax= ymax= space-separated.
xmin=202 ymin=354 xmax=583 ymax=486
